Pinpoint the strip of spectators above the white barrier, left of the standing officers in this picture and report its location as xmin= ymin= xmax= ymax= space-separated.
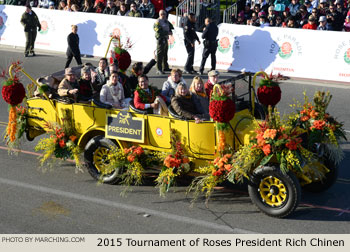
xmin=4 ymin=0 xmax=181 ymax=18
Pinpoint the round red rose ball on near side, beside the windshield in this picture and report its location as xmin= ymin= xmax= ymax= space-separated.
xmin=209 ymin=98 xmax=236 ymax=123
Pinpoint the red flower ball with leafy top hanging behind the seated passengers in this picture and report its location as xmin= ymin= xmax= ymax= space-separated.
xmin=110 ymin=35 xmax=133 ymax=72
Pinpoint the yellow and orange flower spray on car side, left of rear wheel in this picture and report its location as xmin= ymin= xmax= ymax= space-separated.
xmin=35 ymin=110 xmax=82 ymax=171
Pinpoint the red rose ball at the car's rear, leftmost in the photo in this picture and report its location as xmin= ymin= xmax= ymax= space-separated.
xmin=1 ymin=77 xmax=26 ymax=106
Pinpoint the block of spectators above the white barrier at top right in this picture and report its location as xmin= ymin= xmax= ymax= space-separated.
xmin=232 ymin=0 xmax=350 ymax=32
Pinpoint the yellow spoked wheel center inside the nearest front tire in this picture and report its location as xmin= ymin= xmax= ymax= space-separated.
xmin=258 ymin=176 xmax=287 ymax=207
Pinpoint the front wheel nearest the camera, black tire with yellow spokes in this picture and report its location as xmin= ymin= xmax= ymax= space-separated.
xmin=248 ymin=166 xmax=301 ymax=218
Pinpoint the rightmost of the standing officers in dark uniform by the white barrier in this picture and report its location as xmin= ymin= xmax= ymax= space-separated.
xmin=199 ymin=18 xmax=219 ymax=74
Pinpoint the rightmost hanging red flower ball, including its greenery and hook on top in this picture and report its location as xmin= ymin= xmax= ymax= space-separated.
xmin=253 ymin=71 xmax=284 ymax=110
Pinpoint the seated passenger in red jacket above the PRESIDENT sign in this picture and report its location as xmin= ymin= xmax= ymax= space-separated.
xmin=134 ymin=74 xmax=168 ymax=115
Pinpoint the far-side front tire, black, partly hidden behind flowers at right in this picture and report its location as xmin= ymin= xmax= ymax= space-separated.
xmin=303 ymin=157 xmax=339 ymax=193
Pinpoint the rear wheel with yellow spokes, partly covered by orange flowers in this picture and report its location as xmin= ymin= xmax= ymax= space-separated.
xmin=84 ymin=136 xmax=123 ymax=184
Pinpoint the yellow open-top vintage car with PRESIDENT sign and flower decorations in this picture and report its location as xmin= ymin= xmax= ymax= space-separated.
xmin=2 ymin=61 xmax=345 ymax=218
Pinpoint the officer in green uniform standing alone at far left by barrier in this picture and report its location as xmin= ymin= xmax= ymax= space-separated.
xmin=21 ymin=5 xmax=41 ymax=57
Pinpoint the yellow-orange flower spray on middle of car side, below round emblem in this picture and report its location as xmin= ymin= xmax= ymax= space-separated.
xmin=156 ymin=129 xmax=191 ymax=196
